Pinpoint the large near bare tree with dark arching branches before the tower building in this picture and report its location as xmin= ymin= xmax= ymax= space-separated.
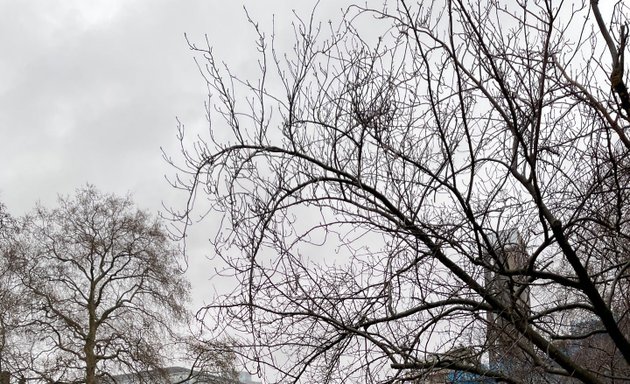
xmin=172 ymin=0 xmax=630 ymax=383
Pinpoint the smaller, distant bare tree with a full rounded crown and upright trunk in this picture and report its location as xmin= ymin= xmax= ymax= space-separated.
xmin=9 ymin=186 xmax=189 ymax=384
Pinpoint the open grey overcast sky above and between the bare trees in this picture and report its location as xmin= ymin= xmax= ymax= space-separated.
xmin=0 ymin=0 xmax=356 ymax=305
